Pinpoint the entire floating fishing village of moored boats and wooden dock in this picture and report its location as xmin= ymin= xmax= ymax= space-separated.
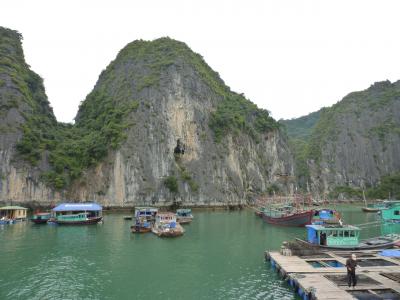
xmin=0 ymin=197 xmax=400 ymax=300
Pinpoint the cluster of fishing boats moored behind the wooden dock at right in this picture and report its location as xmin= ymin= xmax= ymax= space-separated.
xmin=255 ymin=201 xmax=400 ymax=250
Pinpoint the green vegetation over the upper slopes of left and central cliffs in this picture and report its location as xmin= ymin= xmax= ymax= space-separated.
xmin=0 ymin=33 xmax=279 ymax=192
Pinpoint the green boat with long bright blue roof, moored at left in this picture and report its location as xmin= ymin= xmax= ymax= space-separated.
xmin=49 ymin=203 xmax=103 ymax=225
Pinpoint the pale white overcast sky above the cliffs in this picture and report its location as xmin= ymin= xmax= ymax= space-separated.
xmin=0 ymin=0 xmax=400 ymax=122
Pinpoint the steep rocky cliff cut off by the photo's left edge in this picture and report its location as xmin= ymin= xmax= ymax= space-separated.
xmin=0 ymin=27 xmax=56 ymax=206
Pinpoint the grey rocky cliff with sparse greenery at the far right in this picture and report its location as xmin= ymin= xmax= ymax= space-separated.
xmin=282 ymin=81 xmax=400 ymax=196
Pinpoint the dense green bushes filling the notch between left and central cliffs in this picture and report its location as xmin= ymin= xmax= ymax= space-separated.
xmin=17 ymin=92 xmax=138 ymax=189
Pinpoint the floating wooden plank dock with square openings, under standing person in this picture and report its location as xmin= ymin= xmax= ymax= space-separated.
xmin=265 ymin=250 xmax=400 ymax=300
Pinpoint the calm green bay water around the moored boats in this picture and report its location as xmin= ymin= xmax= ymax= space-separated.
xmin=0 ymin=206 xmax=390 ymax=299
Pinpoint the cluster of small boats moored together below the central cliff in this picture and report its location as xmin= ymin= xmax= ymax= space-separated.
xmin=131 ymin=207 xmax=193 ymax=237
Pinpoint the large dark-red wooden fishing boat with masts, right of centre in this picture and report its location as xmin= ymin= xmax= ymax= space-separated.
xmin=262 ymin=205 xmax=314 ymax=227
